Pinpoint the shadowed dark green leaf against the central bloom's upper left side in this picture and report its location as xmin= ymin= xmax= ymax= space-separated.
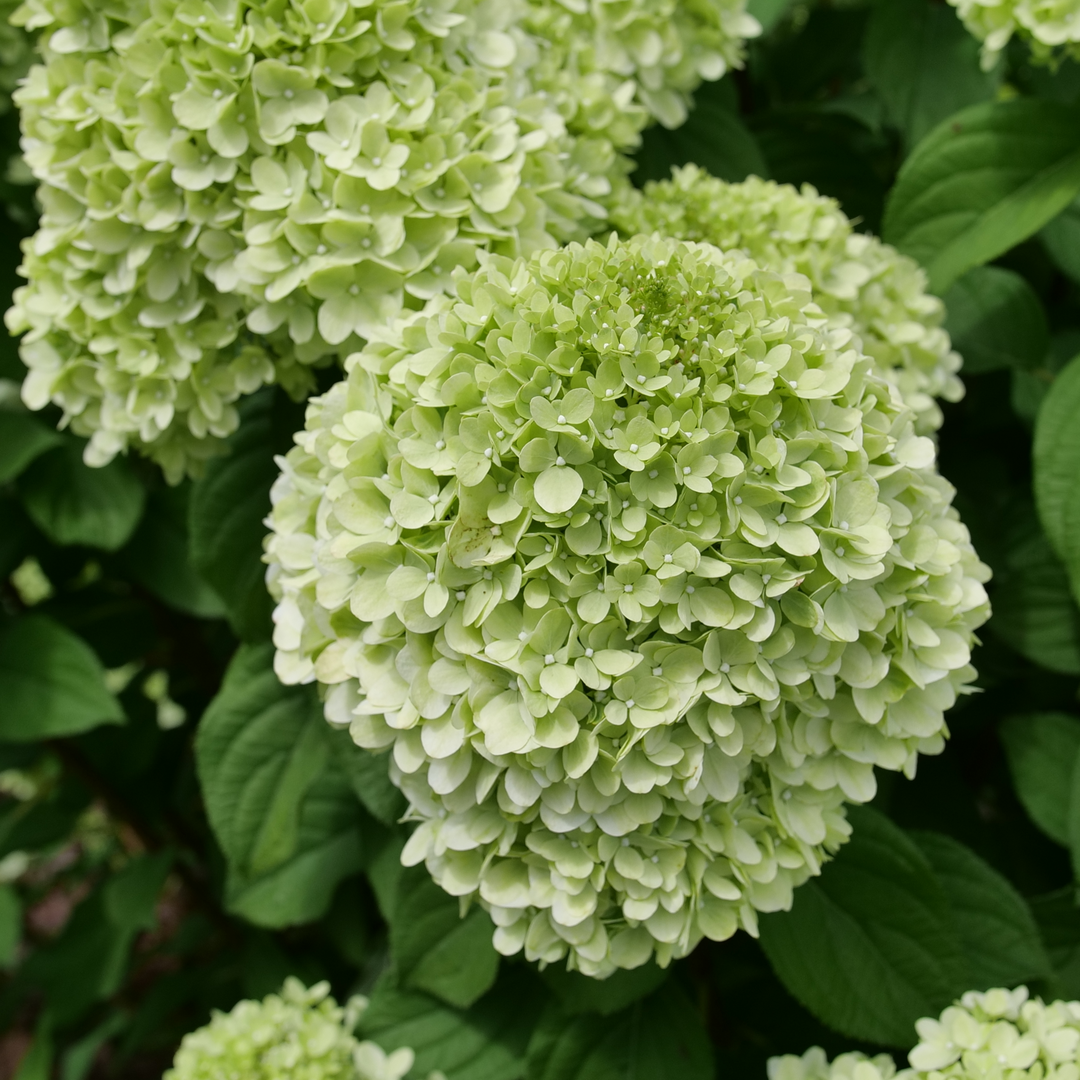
xmin=188 ymin=393 xmax=289 ymax=642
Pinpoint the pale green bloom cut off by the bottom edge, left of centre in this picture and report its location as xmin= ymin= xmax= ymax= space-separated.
xmin=164 ymin=978 xmax=432 ymax=1080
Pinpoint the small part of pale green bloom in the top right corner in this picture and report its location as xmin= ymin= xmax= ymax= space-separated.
xmin=948 ymin=0 xmax=1080 ymax=70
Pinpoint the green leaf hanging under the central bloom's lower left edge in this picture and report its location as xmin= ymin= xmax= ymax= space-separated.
xmin=390 ymin=867 xmax=499 ymax=1008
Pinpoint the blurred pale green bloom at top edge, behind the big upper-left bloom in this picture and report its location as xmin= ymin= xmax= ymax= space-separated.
xmin=527 ymin=0 xmax=761 ymax=137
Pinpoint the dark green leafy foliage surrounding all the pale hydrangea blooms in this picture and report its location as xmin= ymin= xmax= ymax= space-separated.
xmin=6 ymin=0 xmax=1080 ymax=1080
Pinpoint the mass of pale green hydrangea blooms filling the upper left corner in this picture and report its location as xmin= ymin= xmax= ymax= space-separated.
xmin=8 ymin=0 xmax=756 ymax=477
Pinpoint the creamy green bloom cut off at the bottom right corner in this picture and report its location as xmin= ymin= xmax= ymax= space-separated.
xmin=769 ymin=986 xmax=1080 ymax=1080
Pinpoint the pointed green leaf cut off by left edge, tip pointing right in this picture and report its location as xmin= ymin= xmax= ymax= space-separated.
xmin=0 ymin=615 xmax=124 ymax=742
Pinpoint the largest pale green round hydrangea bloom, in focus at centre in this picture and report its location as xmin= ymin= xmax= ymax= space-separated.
xmin=267 ymin=237 xmax=987 ymax=975
